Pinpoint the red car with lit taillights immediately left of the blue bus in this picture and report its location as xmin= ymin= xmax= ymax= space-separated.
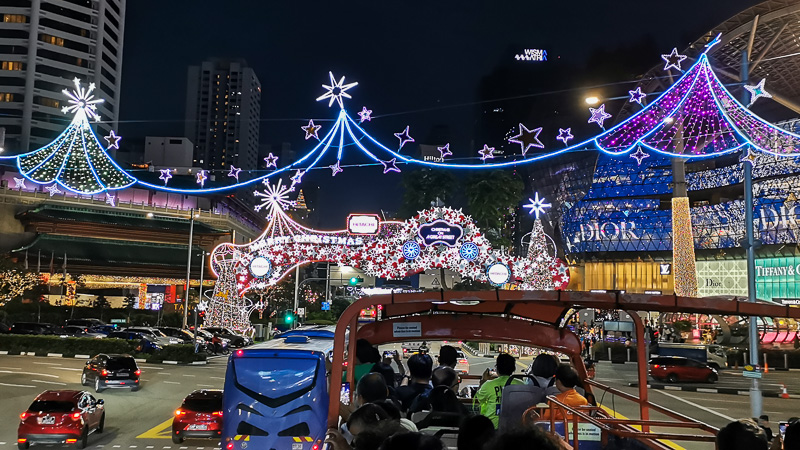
xmin=172 ymin=389 xmax=222 ymax=444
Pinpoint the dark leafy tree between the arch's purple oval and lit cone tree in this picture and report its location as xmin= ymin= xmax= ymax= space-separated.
xmin=464 ymin=170 xmax=524 ymax=247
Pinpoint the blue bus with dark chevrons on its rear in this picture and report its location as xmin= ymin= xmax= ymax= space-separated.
xmin=221 ymin=327 xmax=334 ymax=450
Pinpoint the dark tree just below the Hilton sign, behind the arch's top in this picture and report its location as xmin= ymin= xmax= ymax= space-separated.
xmin=400 ymin=169 xmax=458 ymax=218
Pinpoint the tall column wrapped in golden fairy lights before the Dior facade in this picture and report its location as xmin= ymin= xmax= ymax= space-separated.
xmin=672 ymin=197 xmax=697 ymax=297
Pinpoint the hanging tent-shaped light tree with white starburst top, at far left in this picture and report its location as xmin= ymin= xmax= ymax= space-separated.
xmin=17 ymin=78 xmax=136 ymax=194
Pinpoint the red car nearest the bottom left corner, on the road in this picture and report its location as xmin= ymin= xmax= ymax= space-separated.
xmin=17 ymin=390 xmax=106 ymax=449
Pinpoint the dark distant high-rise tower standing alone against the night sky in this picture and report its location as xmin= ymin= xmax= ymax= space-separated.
xmin=186 ymin=59 xmax=261 ymax=173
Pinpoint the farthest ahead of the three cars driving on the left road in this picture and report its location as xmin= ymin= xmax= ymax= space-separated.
xmin=81 ymin=353 xmax=142 ymax=392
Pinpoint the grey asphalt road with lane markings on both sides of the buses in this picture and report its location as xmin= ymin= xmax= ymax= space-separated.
xmin=0 ymin=344 xmax=800 ymax=450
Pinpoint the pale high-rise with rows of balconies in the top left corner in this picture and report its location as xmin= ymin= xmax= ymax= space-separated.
xmin=0 ymin=0 xmax=126 ymax=153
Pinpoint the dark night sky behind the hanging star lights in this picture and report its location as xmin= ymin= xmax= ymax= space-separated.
xmin=120 ymin=0 xmax=759 ymax=227
